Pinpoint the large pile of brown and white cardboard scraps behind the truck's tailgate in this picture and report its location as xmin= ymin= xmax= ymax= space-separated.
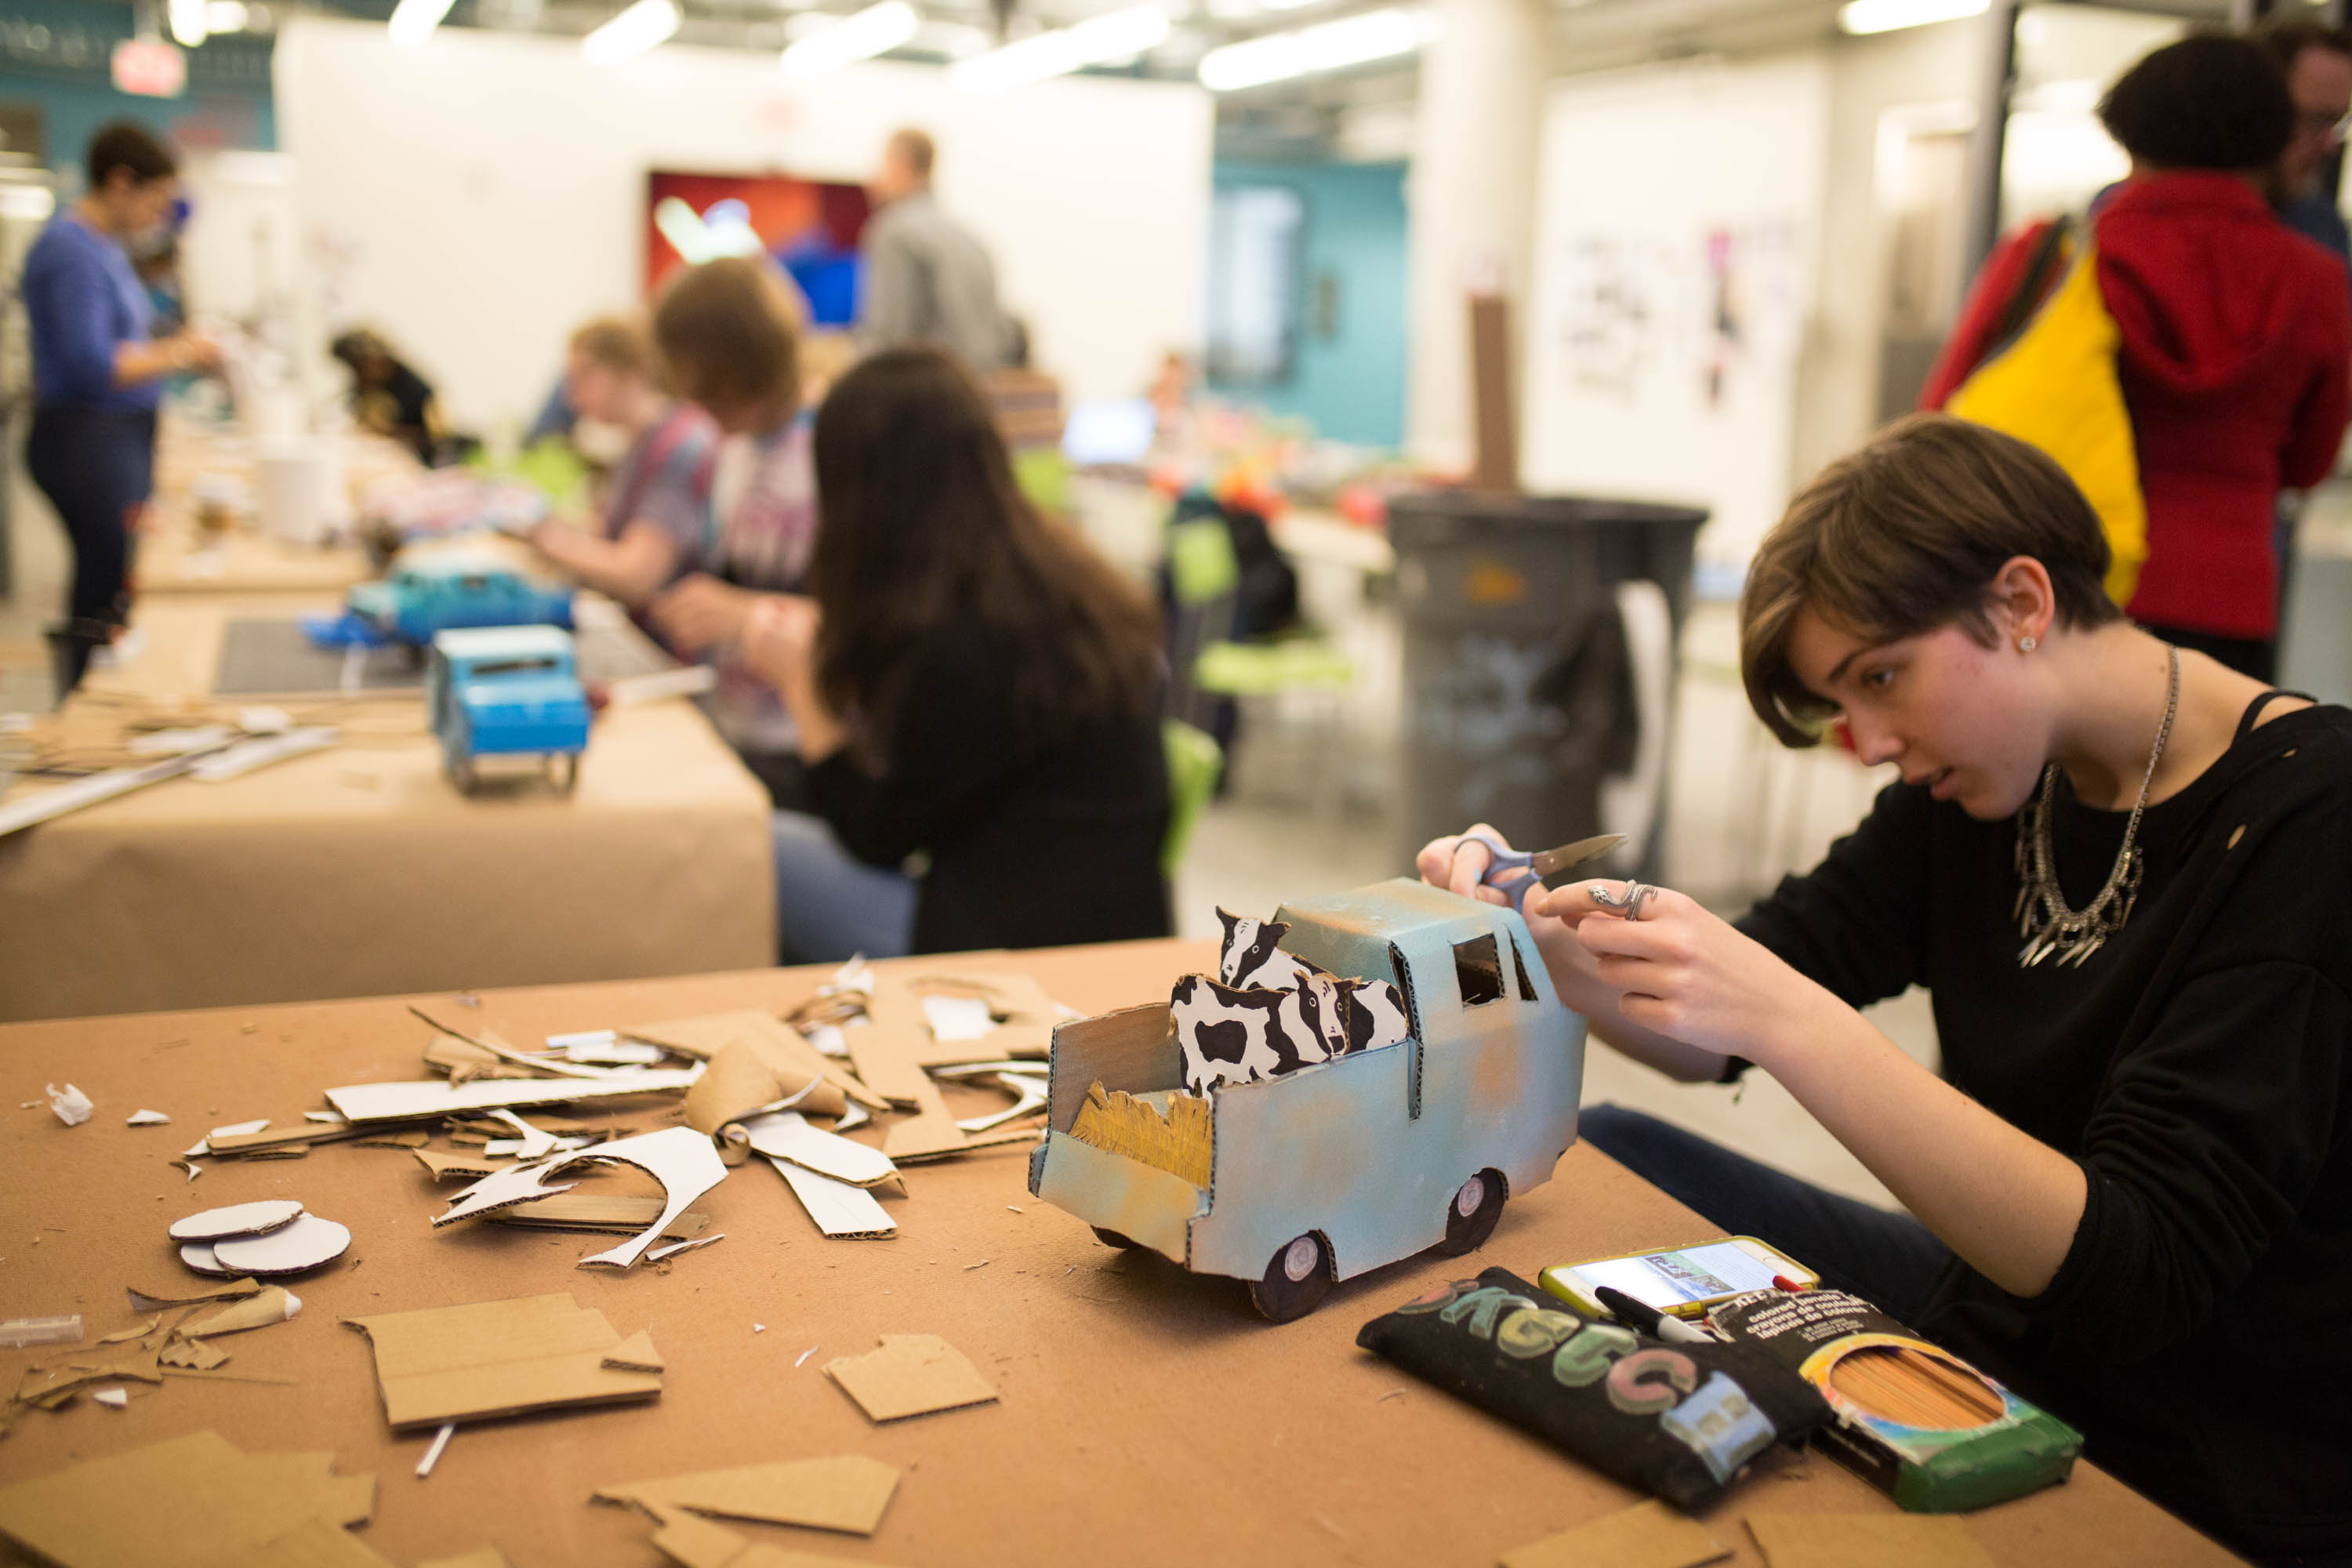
xmin=142 ymin=964 xmax=1068 ymax=1298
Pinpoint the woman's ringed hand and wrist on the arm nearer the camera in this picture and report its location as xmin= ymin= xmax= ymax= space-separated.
xmin=1526 ymin=879 xmax=1844 ymax=1069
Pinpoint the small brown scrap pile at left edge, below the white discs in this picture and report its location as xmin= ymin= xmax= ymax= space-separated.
xmin=0 ymin=1279 xmax=301 ymax=1436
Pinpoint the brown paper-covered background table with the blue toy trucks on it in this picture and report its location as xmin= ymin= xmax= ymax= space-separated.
xmin=0 ymin=597 xmax=776 ymax=1025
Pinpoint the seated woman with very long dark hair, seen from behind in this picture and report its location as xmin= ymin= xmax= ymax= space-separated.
xmin=743 ymin=348 xmax=1169 ymax=959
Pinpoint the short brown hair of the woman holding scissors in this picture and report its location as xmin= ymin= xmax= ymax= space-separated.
xmin=1740 ymin=414 xmax=2124 ymax=746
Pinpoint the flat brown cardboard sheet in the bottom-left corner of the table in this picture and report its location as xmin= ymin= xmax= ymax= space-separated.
xmin=0 ymin=1432 xmax=381 ymax=1568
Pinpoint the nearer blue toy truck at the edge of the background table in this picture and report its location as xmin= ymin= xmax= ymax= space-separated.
xmin=426 ymin=626 xmax=588 ymax=794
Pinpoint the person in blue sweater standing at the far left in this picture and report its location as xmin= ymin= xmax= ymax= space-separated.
xmin=19 ymin=120 xmax=219 ymax=699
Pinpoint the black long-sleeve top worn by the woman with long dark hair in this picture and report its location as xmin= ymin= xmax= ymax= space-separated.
xmin=809 ymin=628 xmax=1171 ymax=952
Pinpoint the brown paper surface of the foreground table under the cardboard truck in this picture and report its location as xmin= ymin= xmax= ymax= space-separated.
xmin=0 ymin=940 xmax=2234 ymax=1568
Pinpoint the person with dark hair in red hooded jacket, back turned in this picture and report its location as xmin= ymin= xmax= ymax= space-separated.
xmin=1919 ymin=33 xmax=2352 ymax=682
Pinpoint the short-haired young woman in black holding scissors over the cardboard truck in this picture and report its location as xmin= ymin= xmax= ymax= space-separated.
xmin=1421 ymin=414 xmax=2352 ymax=1563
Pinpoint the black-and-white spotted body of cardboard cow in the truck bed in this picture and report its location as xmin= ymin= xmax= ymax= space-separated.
xmin=1169 ymin=954 xmax=1406 ymax=1093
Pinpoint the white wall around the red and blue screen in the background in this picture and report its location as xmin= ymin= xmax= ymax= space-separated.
xmin=275 ymin=16 xmax=1214 ymax=428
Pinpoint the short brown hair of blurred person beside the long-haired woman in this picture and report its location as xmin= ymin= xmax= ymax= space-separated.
xmin=654 ymin=256 xmax=800 ymax=416
